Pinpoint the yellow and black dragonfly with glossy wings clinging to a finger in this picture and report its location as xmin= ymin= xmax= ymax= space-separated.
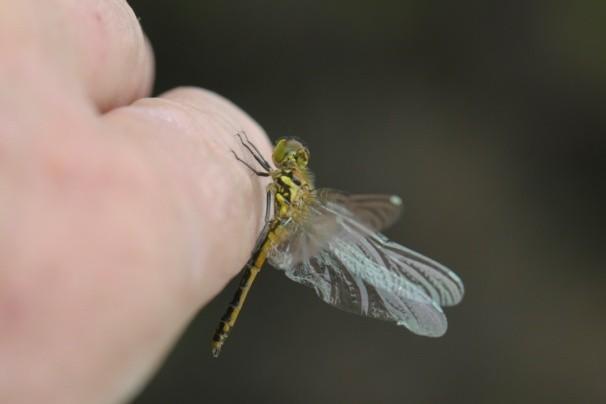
xmin=211 ymin=131 xmax=464 ymax=357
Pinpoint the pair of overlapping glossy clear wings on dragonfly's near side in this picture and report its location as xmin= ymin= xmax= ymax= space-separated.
xmin=269 ymin=191 xmax=463 ymax=336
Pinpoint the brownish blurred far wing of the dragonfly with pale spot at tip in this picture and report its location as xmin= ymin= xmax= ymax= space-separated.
xmin=317 ymin=188 xmax=402 ymax=231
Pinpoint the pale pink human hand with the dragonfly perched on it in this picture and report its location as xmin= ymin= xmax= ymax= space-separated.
xmin=0 ymin=0 xmax=270 ymax=403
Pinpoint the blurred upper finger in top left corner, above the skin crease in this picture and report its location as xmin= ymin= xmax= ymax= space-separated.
xmin=0 ymin=0 xmax=153 ymax=111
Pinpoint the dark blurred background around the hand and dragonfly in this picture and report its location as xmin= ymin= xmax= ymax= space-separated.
xmin=130 ymin=0 xmax=606 ymax=404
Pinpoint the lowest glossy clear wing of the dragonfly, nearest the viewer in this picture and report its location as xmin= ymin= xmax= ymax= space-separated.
xmin=285 ymin=230 xmax=447 ymax=337
